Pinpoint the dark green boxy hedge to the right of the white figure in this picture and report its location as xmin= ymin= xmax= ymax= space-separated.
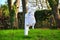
xmin=35 ymin=10 xmax=56 ymax=29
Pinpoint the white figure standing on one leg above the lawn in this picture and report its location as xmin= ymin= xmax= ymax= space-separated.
xmin=24 ymin=0 xmax=37 ymax=35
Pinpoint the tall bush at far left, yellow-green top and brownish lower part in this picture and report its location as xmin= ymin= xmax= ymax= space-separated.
xmin=0 ymin=4 xmax=9 ymax=29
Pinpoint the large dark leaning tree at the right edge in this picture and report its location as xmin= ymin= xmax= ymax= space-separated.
xmin=48 ymin=0 xmax=60 ymax=28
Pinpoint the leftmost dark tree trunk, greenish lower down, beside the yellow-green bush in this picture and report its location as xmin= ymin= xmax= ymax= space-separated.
xmin=7 ymin=0 xmax=14 ymax=28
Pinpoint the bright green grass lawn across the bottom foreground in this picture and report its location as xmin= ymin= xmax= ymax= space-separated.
xmin=0 ymin=29 xmax=60 ymax=40
